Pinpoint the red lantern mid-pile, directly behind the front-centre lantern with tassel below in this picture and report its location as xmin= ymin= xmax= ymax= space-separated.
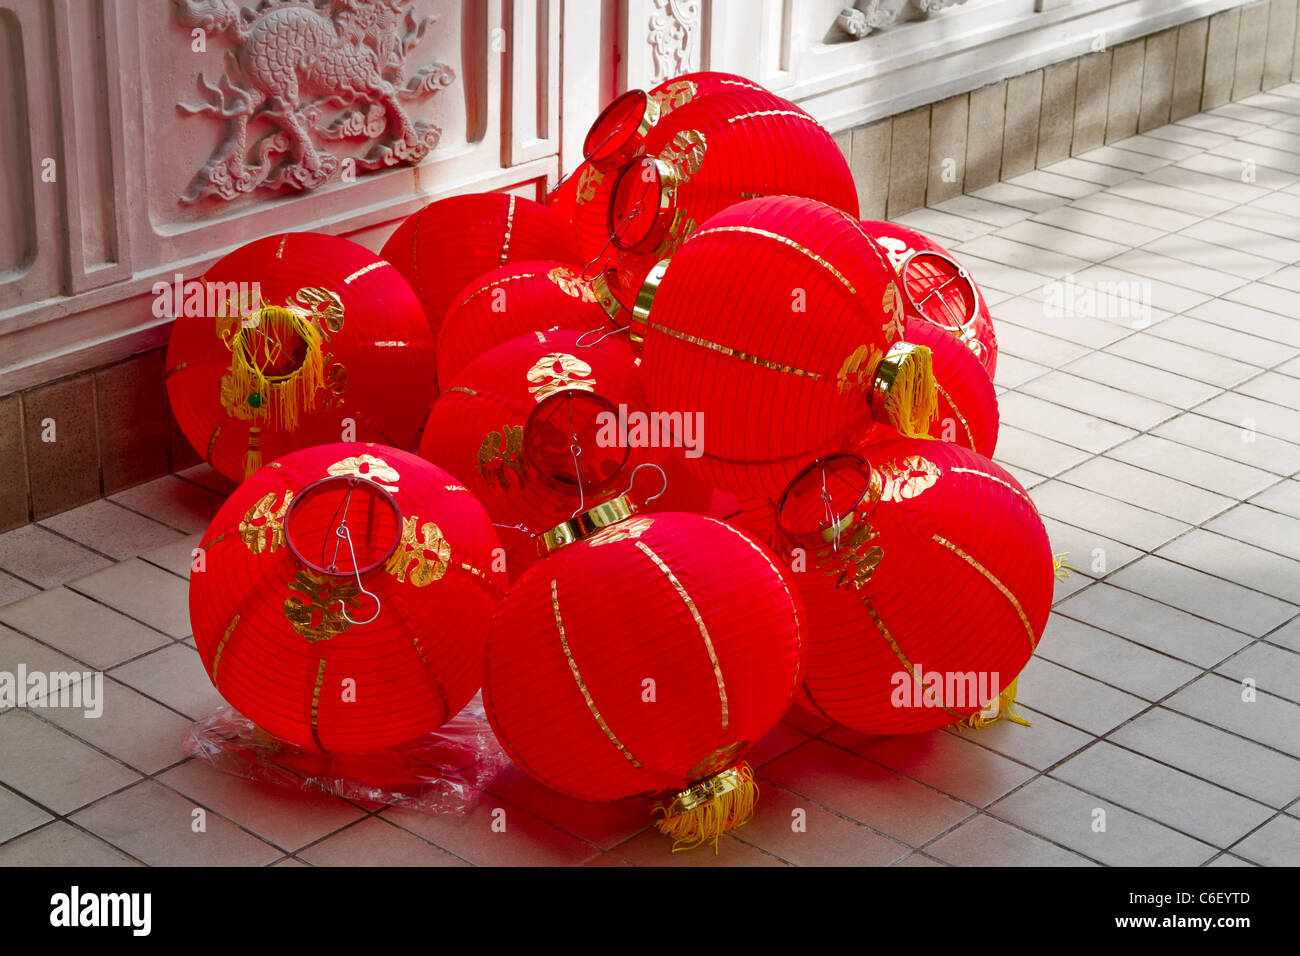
xmin=420 ymin=330 xmax=710 ymax=579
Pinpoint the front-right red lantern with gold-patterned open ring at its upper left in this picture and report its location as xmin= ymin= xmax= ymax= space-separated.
xmin=772 ymin=438 xmax=1054 ymax=734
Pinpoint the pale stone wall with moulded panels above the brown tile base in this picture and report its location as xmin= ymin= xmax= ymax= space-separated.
xmin=0 ymin=0 xmax=1258 ymax=395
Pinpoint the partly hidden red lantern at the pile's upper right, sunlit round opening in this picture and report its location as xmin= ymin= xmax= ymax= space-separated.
xmin=862 ymin=220 xmax=997 ymax=381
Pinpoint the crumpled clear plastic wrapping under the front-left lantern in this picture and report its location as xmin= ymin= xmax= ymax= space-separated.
xmin=183 ymin=695 xmax=510 ymax=814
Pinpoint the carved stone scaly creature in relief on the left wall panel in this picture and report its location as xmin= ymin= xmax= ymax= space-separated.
xmin=173 ymin=0 xmax=456 ymax=203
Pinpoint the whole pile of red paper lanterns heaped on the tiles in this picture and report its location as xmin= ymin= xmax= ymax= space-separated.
xmin=169 ymin=73 xmax=1056 ymax=849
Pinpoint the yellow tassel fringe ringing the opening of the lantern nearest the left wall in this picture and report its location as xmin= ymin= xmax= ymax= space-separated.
xmin=230 ymin=306 xmax=325 ymax=432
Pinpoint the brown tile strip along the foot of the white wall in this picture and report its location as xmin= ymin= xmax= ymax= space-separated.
xmin=0 ymin=0 xmax=1300 ymax=532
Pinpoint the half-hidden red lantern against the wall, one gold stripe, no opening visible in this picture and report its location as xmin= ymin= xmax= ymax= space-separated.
xmin=384 ymin=193 xmax=580 ymax=348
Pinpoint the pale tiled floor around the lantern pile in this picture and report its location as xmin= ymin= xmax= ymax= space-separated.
xmin=0 ymin=93 xmax=1300 ymax=866
